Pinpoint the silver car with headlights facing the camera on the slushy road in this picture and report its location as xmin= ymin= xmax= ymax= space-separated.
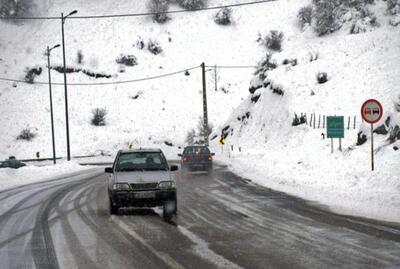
xmin=105 ymin=149 xmax=178 ymax=220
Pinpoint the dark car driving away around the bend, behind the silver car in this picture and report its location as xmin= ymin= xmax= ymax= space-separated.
xmin=178 ymin=146 xmax=215 ymax=172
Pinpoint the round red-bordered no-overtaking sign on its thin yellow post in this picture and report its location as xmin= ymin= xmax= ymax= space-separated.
xmin=361 ymin=99 xmax=383 ymax=171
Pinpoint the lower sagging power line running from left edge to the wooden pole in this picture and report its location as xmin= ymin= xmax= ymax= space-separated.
xmin=0 ymin=66 xmax=200 ymax=86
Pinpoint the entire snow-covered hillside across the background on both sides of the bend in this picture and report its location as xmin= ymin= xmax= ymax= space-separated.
xmin=0 ymin=0 xmax=400 ymax=222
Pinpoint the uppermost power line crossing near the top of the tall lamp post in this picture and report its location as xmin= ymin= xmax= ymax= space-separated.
xmin=0 ymin=0 xmax=276 ymax=20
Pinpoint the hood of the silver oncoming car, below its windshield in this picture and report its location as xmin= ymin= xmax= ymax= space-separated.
xmin=114 ymin=171 xmax=172 ymax=183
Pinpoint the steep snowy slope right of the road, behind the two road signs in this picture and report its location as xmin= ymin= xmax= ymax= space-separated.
xmin=209 ymin=1 xmax=400 ymax=222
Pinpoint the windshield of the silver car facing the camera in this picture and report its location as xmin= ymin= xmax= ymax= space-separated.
xmin=116 ymin=152 xmax=168 ymax=171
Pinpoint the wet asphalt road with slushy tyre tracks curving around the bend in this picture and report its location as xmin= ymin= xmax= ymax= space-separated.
xmin=0 ymin=163 xmax=400 ymax=268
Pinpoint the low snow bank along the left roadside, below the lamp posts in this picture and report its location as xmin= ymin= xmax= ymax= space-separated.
xmin=0 ymin=161 xmax=100 ymax=191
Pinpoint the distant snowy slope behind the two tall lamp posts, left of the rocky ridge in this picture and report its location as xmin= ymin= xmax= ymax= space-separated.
xmin=0 ymin=0 xmax=277 ymax=158
